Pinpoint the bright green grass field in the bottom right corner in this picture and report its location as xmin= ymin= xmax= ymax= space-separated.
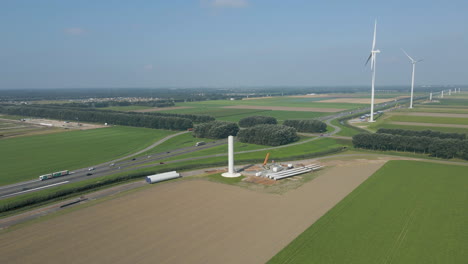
xmin=268 ymin=161 xmax=468 ymax=264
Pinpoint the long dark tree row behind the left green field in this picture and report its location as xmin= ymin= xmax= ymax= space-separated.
xmin=0 ymin=106 xmax=193 ymax=130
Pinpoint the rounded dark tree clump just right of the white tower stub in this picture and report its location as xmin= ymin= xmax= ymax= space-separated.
xmin=237 ymin=124 xmax=299 ymax=146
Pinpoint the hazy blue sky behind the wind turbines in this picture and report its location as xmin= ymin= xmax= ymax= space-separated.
xmin=0 ymin=0 xmax=468 ymax=89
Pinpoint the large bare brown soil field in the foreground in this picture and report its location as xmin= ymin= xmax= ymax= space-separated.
xmin=0 ymin=159 xmax=385 ymax=264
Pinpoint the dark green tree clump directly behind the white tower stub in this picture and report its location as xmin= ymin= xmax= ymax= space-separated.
xmin=193 ymin=121 xmax=239 ymax=139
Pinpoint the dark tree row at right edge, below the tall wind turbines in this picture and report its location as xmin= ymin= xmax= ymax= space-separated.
xmin=353 ymin=133 xmax=468 ymax=160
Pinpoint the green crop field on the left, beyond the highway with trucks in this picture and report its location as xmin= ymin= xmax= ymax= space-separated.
xmin=0 ymin=126 xmax=174 ymax=185
